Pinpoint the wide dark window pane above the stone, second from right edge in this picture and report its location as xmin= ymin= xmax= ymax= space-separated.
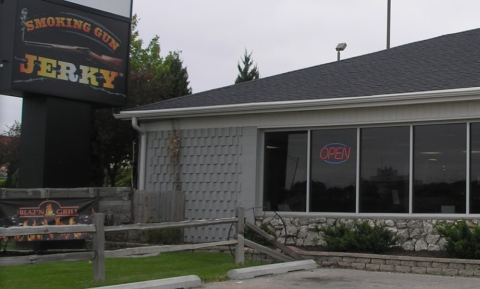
xmin=413 ymin=124 xmax=467 ymax=214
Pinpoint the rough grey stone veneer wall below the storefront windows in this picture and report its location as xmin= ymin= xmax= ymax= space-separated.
xmin=257 ymin=216 xmax=480 ymax=251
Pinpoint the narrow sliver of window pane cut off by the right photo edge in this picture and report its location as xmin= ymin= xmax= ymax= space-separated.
xmin=470 ymin=123 xmax=480 ymax=214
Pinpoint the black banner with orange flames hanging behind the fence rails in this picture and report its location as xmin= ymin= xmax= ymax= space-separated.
xmin=0 ymin=199 xmax=97 ymax=242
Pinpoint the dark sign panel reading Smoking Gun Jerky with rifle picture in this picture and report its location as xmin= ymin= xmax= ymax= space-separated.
xmin=12 ymin=0 xmax=130 ymax=106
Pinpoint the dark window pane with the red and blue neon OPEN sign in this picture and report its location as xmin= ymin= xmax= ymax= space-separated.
xmin=310 ymin=129 xmax=357 ymax=212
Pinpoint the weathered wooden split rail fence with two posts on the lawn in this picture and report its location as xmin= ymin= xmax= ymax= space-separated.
xmin=0 ymin=207 xmax=245 ymax=282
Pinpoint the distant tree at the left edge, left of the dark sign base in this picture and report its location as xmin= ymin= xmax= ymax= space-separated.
xmin=0 ymin=121 xmax=21 ymax=188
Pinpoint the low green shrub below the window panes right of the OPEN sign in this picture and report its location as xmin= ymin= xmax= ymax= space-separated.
xmin=319 ymin=222 xmax=397 ymax=253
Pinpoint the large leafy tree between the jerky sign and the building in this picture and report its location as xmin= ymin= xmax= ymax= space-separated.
xmin=91 ymin=15 xmax=192 ymax=186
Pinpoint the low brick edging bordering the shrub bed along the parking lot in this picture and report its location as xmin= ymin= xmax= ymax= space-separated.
xmin=299 ymin=251 xmax=480 ymax=277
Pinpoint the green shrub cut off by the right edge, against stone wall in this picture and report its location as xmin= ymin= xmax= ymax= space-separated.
xmin=436 ymin=221 xmax=480 ymax=259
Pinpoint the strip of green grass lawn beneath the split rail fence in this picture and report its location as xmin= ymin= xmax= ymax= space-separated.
xmin=0 ymin=252 xmax=260 ymax=289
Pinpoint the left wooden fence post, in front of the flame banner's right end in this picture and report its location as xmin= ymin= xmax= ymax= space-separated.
xmin=93 ymin=213 xmax=105 ymax=282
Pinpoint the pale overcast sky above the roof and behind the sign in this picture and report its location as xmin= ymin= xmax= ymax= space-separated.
xmin=0 ymin=0 xmax=480 ymax=132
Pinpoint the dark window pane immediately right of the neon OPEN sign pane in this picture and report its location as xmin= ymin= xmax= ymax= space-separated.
xmin=360 ymin=127 xmax=410 ymax=213
